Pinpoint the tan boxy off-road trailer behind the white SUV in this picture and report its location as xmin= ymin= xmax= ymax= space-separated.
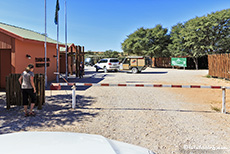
xmin=121 ymin=56 xmax=150 ymax=73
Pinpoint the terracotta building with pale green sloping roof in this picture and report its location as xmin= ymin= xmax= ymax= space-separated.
xmin=0 ymin=23 xmax=65 ymax=88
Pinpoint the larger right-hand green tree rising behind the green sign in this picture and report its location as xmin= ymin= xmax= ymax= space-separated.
xmin=168 ymin=9 xmax=230 ymax=69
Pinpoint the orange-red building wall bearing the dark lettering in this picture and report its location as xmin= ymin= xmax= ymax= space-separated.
xmin=12 ymin=40 xmax=57 ymax=81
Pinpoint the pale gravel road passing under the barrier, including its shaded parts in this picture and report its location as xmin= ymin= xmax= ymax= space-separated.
xmin=0 ymin=67 xmax=230 ymax=154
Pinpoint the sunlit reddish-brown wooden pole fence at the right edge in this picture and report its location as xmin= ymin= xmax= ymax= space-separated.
xmin=208 ymin=54 xmax=230 ymax=79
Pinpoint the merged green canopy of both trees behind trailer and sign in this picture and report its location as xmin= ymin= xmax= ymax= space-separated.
xmin=122 ymin=9 xmax=230 ymax=67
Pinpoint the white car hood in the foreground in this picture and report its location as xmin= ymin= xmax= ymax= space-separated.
xmin=0 ymin=132 xmax=154 ymax=154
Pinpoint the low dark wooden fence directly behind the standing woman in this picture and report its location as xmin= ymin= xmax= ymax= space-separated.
xmin=6 ymin=74 xmax=45 ymax=109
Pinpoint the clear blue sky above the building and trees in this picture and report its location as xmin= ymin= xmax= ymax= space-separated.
xmin=0 ymin=0 xmax=230 ymax=51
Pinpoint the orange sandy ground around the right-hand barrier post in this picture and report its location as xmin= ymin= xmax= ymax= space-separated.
xmin=167 ymin=76 xmax=230 ymax=134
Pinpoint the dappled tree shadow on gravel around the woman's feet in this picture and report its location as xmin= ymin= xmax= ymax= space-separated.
xmin=0 ymin=95 xmax=98 ymax=134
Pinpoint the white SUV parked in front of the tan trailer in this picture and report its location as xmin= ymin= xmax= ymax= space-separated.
xmin=94 ymin=58 xmax=120 ymax=73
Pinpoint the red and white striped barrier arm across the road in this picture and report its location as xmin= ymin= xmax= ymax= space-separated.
xmin=55 ymin=83 xmax=230 ymax=89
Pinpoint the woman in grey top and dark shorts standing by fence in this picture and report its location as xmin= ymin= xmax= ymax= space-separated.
xmin=18 ymin=64 xmax=36 ymax=117
